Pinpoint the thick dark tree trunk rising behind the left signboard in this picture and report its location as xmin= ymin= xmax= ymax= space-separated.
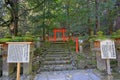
xmin=5 ymin=0 xmax=19 ymax=36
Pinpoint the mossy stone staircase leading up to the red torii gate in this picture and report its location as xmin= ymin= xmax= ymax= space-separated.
xmin=40 ymin=42 xmax=76 ymax=71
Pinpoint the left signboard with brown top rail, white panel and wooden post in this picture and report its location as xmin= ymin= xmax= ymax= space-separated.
xmin=7 ymin=42 xmax=31 ymax=80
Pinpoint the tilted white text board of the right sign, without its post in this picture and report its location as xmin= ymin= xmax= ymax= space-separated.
xmin=100 ymin=40 xmax=116 ymax=59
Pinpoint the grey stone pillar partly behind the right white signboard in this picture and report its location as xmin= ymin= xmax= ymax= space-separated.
xmin=96 ymin=51 xmax=106 ymax=71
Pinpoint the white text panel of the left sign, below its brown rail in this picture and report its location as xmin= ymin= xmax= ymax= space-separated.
xmin=7 ymin=44 xmax=30 ymax=63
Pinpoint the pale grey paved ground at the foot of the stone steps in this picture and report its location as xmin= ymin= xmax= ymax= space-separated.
xmin=34 ymin=69 xmax=101 ymax=80
